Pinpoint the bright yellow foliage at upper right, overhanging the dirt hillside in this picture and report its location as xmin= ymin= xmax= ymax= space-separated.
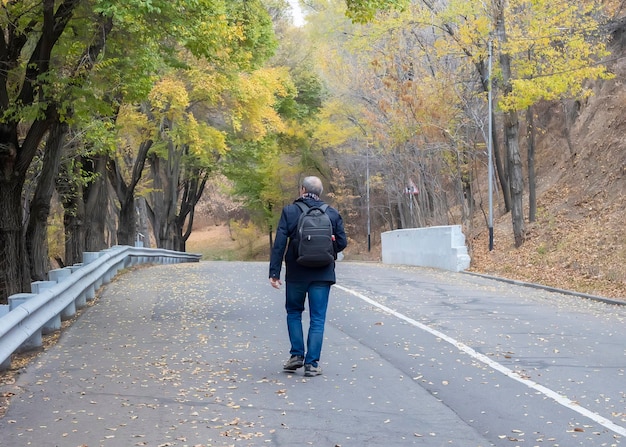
xmin=496 ymin=0 xmax=611 ymax=111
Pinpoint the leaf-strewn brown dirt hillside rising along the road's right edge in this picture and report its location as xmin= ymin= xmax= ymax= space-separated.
xmin=469 ymin=29 xmax=626 ymax=301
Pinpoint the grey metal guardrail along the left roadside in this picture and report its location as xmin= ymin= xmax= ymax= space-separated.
xmin=0 ymin=245 xmax=201 ymax=370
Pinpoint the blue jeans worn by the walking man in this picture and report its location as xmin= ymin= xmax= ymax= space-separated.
xmin=285 ymin=281 xmax=331 ymax=366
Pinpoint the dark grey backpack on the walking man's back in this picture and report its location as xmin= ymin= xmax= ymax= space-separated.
xmin=296 ymin=202 xmax=336 ymax=267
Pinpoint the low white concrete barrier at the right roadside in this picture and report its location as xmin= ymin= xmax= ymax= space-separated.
xmin=381 ymin=225 xmax=470 ymax=272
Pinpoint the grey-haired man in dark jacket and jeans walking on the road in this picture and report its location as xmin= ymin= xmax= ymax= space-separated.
xmin=269 ymin=176 xmax=348 ymax=377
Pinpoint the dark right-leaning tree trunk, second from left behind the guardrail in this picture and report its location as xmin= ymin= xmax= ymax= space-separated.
xmin=25 ymin=121 xmax=68 ymax=281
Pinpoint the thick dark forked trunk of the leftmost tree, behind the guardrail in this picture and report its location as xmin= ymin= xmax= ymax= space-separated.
xmin=0 ymin=0 xmax=106 ymax=301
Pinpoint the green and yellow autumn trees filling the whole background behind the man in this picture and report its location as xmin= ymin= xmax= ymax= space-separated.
xmin=0 ymin=0 xmax=620 ymax=300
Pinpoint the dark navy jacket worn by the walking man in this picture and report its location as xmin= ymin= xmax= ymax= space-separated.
xmin=270 ymin=198 xmax=348 ymax=284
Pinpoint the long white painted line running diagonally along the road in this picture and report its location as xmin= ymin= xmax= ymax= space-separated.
xmin=334 ymin=284 xmax=626 ymax=436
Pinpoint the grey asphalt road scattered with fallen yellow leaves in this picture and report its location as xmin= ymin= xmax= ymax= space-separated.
xmin=0 ymin=262 xmax=626 ymax=447
